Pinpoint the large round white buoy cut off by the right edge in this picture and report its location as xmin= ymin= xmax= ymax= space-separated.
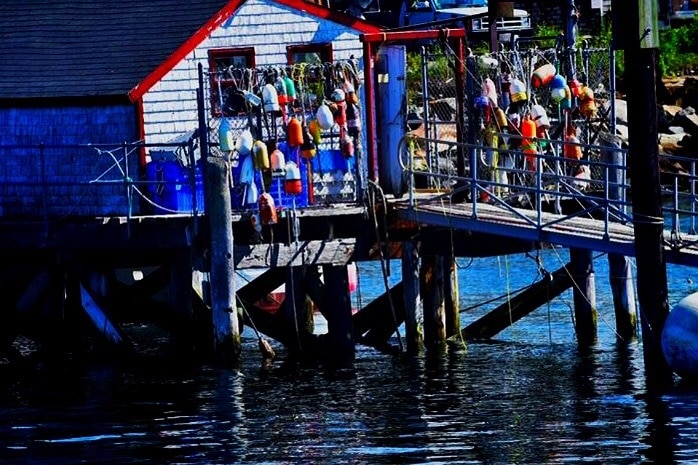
xmin=662 ymin=293 xmax=698 ymax=378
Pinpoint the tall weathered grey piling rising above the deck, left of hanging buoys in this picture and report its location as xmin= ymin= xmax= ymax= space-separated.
xmin=205 ymin=157 xmax=241 ymax=364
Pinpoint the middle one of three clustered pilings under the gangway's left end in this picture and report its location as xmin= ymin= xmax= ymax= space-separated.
xmin=419 ymin=255 xmax=446 ymax=348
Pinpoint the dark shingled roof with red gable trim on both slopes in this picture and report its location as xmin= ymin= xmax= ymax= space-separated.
xmin=0 ymin=0 xmax=377 ymax=100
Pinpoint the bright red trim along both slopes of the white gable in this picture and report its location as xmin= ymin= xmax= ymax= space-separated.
xmin=128 ymin=0 xmax=382 ymax=102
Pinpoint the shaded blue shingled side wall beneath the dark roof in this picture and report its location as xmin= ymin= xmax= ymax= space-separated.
xmin=0 ymin=104 xmax=140 ymax=218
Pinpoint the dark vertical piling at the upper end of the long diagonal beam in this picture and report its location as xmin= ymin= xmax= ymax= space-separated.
xmin=570 ymin=249 xmax=596 ymax=345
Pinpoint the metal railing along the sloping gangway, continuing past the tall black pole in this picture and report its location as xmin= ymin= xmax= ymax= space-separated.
xmin=401 ymin=130 xmax=698 ymax=254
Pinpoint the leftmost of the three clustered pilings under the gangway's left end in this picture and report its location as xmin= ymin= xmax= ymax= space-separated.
xmin=402 ymin=241 xmax=423 ymax=354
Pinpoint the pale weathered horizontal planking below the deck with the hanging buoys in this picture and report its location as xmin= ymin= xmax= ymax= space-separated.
xmin=234 ymin=239 xmax=356 ymax=269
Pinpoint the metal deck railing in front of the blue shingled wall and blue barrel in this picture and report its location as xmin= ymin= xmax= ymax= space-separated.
xmin=0 ymin=139 xmax=203 ymax=222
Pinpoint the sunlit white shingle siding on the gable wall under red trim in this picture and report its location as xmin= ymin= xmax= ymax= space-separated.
xmin=143 ymin=0 xmax=363 ymax=143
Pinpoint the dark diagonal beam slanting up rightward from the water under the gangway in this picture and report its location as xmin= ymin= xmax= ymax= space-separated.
xmin=461 ymin=263 xmax=572 ymax=340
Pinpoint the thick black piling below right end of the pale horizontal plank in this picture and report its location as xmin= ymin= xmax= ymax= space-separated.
xmin=322 ymin=265 xmax=356 ymax=367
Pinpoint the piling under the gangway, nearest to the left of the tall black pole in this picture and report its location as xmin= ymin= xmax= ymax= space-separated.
xmin=608 ymin=254 xmax=637 ymax=341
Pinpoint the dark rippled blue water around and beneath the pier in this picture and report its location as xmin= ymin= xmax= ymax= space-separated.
xmin=0 ymin=251 xmax=698 ymax=464
